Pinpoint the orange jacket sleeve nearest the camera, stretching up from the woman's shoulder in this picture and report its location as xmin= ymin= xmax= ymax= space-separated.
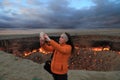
xmin=50 ymin=40 xmax=71 ymax=54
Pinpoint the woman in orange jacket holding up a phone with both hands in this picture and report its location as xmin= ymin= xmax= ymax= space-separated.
xmin=40 ymin=33 xmax=73 ymax=80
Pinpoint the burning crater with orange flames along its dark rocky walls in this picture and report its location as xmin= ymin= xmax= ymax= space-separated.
xmin=0 ymin=35 xmax=120 ymax=71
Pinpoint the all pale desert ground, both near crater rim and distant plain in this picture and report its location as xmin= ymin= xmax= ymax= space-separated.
xmin=0 ymin=29 xmax=120 ymax=80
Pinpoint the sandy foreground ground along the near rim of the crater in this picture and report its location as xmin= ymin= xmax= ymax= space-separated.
xmin=0 ymin=51 xmax=120 ymax=80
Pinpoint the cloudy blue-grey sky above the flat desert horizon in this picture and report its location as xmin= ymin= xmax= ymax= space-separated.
xmin=0 ymin=0 xmax=120 ymax=29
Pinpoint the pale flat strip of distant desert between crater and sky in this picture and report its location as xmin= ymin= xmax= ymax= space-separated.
xmin=0 ymin=29 xmax=120 ymax=36
